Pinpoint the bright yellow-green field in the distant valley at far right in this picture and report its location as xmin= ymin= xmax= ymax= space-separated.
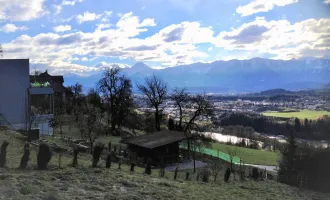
xmin=262 ymin=110 xmax=330 ymax=120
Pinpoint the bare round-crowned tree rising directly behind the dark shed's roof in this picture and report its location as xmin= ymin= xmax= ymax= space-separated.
xmin=137 ymin=75 xmax=167 ymax=131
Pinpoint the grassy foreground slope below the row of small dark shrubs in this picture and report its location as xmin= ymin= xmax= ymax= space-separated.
xmin=0 ymin=131 xmax=330 ymax=200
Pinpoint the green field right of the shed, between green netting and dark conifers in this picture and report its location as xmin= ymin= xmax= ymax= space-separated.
xmin=211 ymin=143 xmax=279 ymax=166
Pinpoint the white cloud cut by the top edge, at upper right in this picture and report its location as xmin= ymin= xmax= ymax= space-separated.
xmin=236 ymin=0 xmax=298 ymax=17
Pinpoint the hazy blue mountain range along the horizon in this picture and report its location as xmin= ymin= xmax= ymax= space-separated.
xmin=64 ymin=58 xmax=330 ymax=93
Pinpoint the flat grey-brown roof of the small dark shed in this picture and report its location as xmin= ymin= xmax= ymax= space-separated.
xmin=126 ymin=130 xmax=186 ymax=149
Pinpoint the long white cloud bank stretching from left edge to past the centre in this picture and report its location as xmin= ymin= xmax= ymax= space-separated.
xmin=3 ymin=13 xmax=213 ymax=74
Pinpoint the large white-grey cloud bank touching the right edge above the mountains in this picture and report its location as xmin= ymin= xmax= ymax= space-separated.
xmin=215 ymin=17 xmax=330 ymax=59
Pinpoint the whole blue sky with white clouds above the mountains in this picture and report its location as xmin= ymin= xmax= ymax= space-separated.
xmin=0 ymin=0 xmax=330 ymax=75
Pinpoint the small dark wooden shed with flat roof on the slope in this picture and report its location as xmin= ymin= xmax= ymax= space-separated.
xmin=125 ymin=130 xmax=187 ymax=166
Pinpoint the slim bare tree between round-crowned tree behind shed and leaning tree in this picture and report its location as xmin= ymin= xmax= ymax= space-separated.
xmin=171 ymin=88 xmax=189 ymax=130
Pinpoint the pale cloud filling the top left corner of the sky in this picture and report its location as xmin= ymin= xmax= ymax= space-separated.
xmin=0 ymin=0 xmax=47 ymax=21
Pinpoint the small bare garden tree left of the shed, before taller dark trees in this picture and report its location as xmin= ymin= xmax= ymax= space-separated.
xmin=78 ymin=104 xmax=102 ymax=154
